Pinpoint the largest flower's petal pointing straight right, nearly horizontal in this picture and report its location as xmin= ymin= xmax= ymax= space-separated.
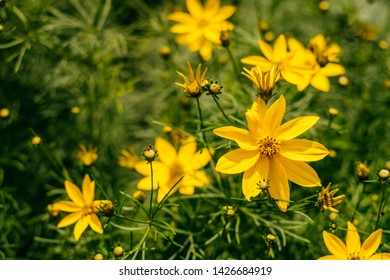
xmin=279 ymin=139 xmax=329 ymax=161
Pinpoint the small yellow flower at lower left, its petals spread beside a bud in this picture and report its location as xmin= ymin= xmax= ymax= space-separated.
xmin=54 ymin=175 xmax=103 ymax=240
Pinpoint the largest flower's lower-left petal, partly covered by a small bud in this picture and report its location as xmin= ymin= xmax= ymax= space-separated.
xmin=242 ymin=158 xmax=269 ymax=200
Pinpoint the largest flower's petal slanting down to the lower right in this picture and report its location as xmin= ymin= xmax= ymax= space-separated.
xmin=275 ymin=155 xmax=321 ymax=187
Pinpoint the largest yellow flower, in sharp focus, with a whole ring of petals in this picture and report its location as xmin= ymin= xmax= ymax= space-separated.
xmin=214 ymin=96 xmax=328 ymax=211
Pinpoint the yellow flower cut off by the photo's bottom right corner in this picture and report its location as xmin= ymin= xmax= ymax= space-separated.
xmin=319 ymin=222 xmax=390 ymax=260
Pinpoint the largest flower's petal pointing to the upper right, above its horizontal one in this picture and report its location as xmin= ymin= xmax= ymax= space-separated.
xmin=277 ymin=116 xmax=320 ymax=140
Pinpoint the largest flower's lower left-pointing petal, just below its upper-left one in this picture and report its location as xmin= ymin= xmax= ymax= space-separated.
xmin=215 ymin=149 xmax=260 ymax=174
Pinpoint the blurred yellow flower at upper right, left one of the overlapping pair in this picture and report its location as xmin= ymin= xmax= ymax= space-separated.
xmin=241 ymin=34 xmax=311 ymax=88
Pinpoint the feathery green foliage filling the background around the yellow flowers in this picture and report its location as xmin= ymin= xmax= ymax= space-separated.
xmin=0 ymin=0 xmax=390 ymax=259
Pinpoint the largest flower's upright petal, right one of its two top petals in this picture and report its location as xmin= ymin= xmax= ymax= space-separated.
xmin=264 ymin=95 xmax=286 ymax=137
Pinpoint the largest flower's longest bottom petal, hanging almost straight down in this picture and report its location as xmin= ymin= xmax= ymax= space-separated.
xmin=268 ymin=158 xmax=290 ymax=212
